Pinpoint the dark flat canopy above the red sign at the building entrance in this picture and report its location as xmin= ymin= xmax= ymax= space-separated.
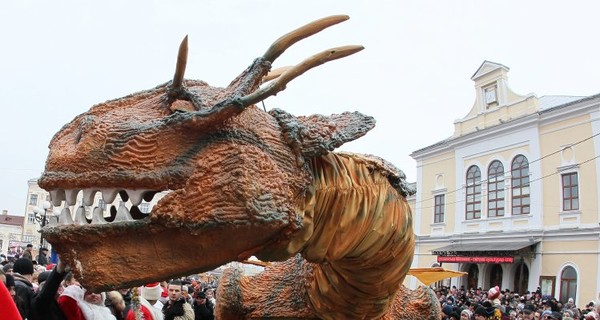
xmin=431 ymin=241 xmax=539 ymax=256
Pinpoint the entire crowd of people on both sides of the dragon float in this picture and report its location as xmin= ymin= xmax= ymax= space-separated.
xmin=0 ymin=246 xmax=600 ymax=320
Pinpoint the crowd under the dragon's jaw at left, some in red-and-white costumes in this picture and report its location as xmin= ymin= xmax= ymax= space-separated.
xmin=0 ymin=250 xmax=216 ymax=320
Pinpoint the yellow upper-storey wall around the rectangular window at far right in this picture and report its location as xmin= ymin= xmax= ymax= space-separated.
xmin=532 ymin=115 xmax=598 ymax=226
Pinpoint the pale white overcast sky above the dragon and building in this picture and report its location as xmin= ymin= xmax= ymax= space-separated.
xmin=0 ymin=0 xmax=600 ymax=215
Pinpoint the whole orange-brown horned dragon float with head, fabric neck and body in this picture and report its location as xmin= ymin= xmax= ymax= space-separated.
xmin=39 ymin=16 xmax=441 ymax=320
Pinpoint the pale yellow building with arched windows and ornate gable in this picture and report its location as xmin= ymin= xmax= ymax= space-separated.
xmin=411 ymin=61 xmax=600 ymax=305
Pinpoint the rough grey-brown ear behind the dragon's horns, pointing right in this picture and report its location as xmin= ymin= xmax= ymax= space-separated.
xmin=269 ymin=109 xmax=375 ymax=158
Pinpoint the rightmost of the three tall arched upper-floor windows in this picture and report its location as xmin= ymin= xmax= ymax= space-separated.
xmin=511 ymin=155 xmax=530 ymax=215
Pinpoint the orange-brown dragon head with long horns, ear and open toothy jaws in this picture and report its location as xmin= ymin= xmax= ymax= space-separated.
xmin=39 ymin=16 xmax=382 ymax=290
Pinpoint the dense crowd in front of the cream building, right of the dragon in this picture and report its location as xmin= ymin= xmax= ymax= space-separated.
xmin=435 ymin=286 xmax=600 ymax=320
